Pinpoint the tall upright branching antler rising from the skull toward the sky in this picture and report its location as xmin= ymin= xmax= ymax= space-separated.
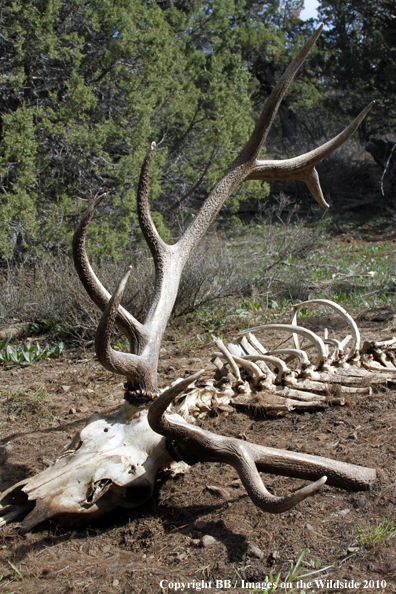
xmin=73 ymin=26 xmax=372 ymax=401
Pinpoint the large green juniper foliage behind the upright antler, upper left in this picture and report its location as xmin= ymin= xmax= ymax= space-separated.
xmin=0 ymin=0 xmax=313 ymax=259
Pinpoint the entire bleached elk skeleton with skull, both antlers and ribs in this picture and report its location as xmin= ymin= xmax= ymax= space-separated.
xmin=0 ymin=28 xmax=380 ymax=531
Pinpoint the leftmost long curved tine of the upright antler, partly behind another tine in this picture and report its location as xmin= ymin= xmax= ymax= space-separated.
xmin=73 ymin=193 xmax=145 ymax=352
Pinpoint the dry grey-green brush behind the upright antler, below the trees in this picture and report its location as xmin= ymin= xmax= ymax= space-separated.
xmin=0 ymin=216 xmax=318 ymax=340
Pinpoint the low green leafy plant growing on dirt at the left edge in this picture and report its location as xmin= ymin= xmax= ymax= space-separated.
xmin=0 ymin=332 xmax=65 ymax=367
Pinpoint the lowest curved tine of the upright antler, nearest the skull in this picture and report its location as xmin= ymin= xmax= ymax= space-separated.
xmin=95 ymin=266 xmax=157 ymax=396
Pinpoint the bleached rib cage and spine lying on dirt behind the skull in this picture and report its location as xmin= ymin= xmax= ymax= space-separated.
xmin=207 ymin=299 xmax=396 ymax=416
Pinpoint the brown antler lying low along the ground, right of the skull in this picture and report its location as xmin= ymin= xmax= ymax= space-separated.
xmin=148 ymin=370 xmax=376 ymax=513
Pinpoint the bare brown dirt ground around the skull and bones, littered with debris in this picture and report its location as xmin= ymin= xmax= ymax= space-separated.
xmin=0 ymin=310 xmax=396 ymax=594
